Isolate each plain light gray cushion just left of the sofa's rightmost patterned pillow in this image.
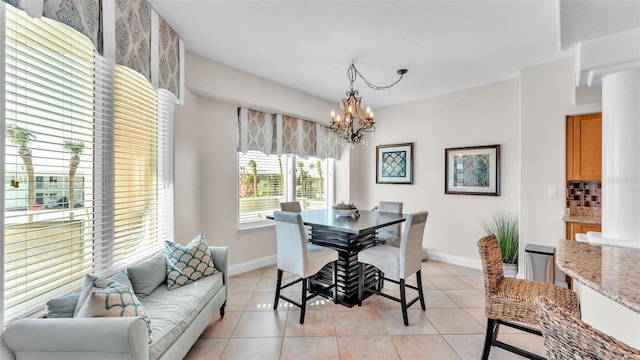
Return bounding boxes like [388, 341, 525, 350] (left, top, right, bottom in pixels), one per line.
[127, 251, 167, 299]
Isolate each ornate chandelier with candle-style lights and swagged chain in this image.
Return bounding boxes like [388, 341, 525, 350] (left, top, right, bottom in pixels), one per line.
[329, 63, 408, 146]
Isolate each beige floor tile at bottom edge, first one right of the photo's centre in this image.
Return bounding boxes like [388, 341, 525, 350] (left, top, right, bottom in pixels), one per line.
[338, 336, 400, 360]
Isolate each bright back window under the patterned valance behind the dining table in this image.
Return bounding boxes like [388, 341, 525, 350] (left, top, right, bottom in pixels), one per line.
[238, 151, 332, 229]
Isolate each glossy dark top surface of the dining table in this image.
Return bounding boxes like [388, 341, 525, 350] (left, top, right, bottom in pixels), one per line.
[267, 209, 408, 234]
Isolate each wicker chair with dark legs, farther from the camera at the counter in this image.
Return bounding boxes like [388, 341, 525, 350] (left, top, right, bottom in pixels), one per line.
[478, 235, 580, 359]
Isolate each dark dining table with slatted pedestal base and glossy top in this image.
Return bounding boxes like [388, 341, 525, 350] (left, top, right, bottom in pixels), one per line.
[267, 209, 408, 307]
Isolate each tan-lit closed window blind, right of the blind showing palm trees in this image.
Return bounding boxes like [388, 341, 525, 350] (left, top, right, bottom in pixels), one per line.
[112, 65, 158, 270]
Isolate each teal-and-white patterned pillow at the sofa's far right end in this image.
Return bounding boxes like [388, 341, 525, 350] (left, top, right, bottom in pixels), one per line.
[165, 234, 216, 290]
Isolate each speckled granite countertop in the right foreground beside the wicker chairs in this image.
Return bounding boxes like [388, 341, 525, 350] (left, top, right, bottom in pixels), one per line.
[556, 240, 640, 313]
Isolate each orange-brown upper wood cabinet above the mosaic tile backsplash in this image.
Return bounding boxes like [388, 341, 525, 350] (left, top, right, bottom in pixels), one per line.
[567, 113, 602, 180]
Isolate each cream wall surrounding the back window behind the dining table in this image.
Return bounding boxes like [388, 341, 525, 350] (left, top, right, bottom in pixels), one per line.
[175, 54, 338, 273]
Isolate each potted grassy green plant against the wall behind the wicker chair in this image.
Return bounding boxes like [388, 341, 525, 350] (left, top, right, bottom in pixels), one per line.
[482, 211, 520, 277]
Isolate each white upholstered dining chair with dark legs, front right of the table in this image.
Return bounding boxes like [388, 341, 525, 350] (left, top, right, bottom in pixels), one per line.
[358, 211, 429, 326]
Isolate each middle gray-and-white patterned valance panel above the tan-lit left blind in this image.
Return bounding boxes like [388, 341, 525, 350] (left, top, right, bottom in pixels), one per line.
[115, 0, 151, 81]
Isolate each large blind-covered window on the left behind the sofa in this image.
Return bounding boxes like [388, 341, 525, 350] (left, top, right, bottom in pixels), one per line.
[0, 5, 173, 322]
